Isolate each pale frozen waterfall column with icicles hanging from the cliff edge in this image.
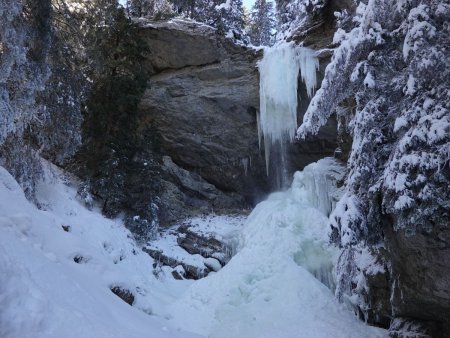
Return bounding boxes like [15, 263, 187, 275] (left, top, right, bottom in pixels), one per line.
[257, 43, 319, 174]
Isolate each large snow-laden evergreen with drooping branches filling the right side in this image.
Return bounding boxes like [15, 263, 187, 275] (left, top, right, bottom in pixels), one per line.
[299, 0, 450, 321]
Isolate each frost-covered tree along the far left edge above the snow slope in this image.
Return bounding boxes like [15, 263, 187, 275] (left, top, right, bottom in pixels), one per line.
[0, 0, 51, 197]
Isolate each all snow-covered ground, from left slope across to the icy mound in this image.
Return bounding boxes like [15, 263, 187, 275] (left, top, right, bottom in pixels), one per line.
[0, 163, 385, 338]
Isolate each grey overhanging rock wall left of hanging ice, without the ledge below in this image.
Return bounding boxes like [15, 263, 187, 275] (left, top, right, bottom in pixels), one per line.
[140, 20, 269, 206]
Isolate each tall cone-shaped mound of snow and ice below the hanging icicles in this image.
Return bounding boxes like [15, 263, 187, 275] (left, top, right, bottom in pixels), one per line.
[169, 160, 385, 337]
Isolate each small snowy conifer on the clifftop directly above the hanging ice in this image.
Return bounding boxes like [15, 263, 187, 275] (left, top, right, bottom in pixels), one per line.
[249, 0, 276, 46]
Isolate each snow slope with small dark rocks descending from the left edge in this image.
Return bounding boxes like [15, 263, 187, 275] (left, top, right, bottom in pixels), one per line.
[0, 162, 196, 338]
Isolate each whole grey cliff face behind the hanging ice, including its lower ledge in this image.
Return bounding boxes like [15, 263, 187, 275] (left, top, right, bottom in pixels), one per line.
[140, 20, 336, 223]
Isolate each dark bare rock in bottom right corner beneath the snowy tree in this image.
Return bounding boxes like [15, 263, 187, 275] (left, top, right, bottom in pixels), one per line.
[385, 222, 450, 337]
